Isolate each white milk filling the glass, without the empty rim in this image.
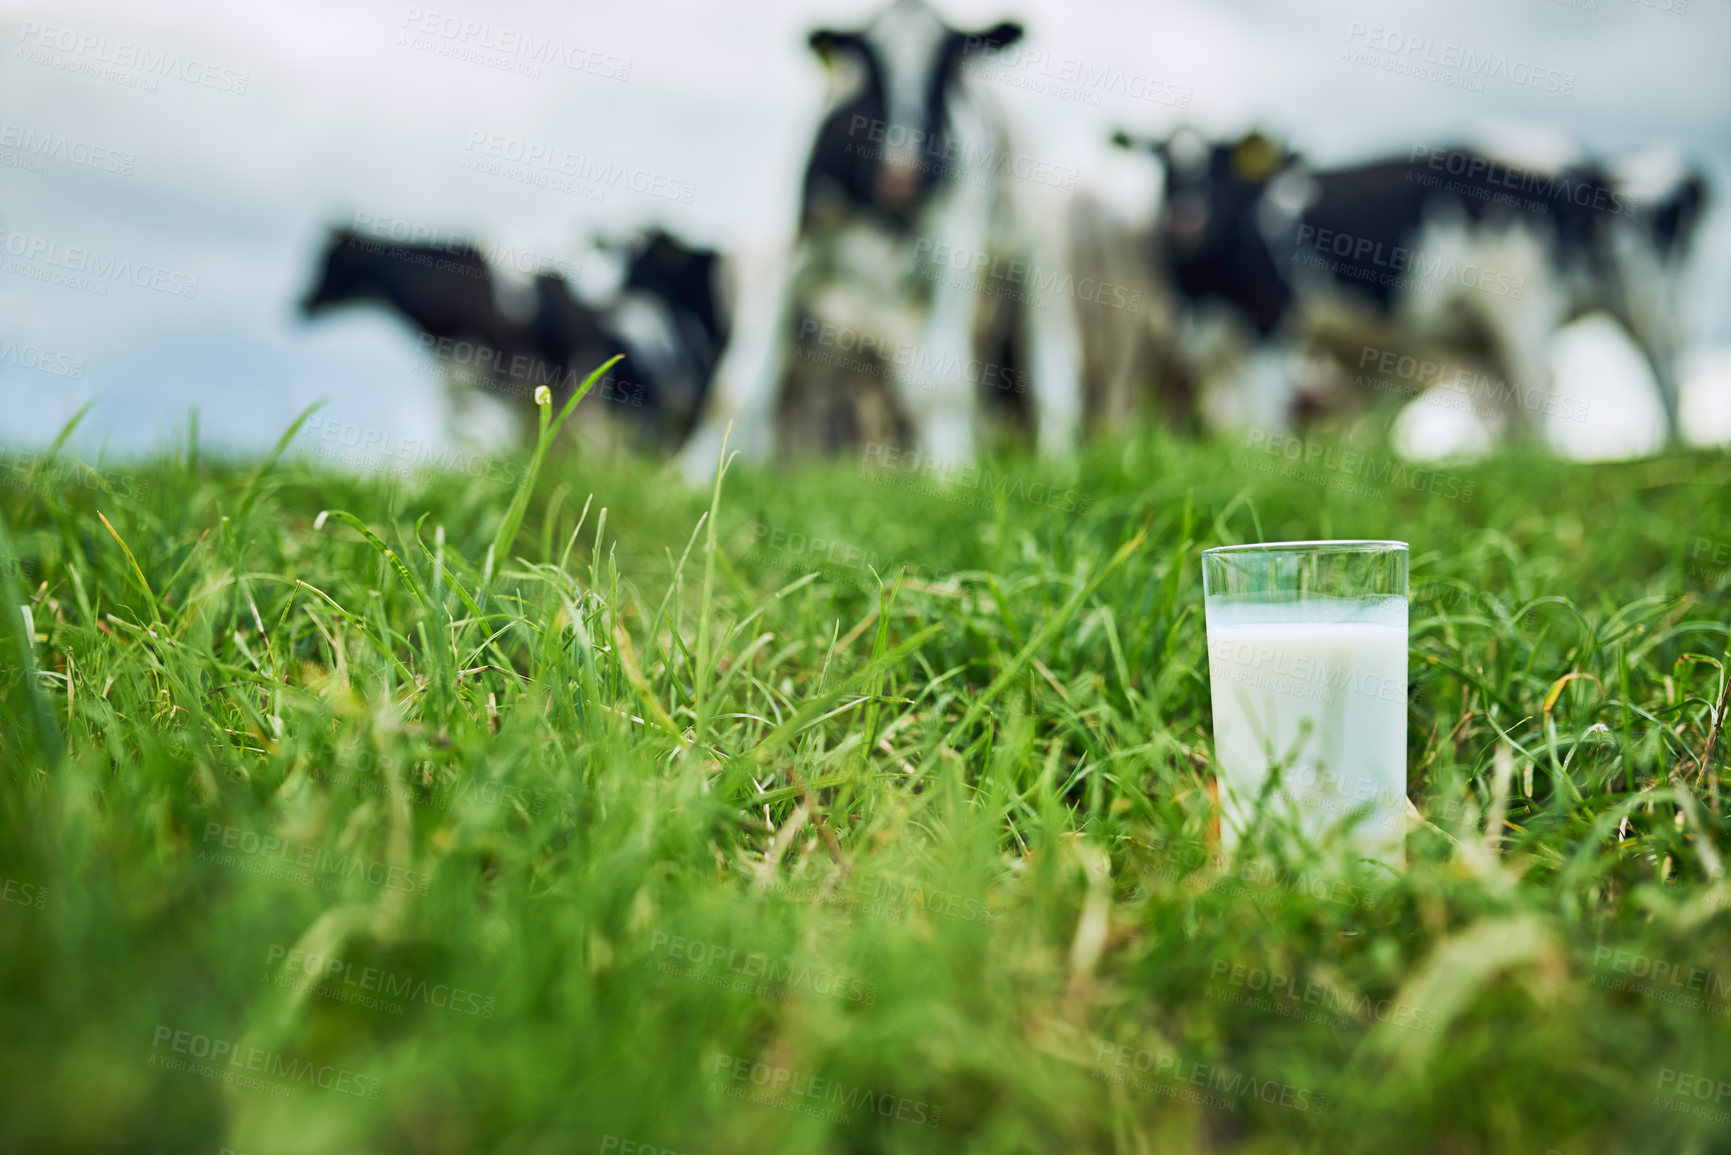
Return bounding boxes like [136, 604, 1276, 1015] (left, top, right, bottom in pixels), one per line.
[1207, 597, 1407, 866]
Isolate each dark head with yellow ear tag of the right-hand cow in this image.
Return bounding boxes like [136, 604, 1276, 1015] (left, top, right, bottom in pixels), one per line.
[1113, 128, 1300, 263]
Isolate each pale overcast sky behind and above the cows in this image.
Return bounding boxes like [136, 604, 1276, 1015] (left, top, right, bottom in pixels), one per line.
[0, 0, 1731, 452]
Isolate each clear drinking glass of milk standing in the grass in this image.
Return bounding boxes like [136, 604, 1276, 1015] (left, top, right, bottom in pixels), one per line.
[1201, 542, 1407, 868]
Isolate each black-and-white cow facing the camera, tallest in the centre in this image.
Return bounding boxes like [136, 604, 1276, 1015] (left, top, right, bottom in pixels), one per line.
[682, 0, 1078, 481]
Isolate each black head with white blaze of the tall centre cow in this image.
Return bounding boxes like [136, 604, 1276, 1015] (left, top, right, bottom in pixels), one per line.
[803, 0, 1021, 225]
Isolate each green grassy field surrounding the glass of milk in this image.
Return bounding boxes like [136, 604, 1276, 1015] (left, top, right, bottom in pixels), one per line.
[0, 393, 1731, 1155]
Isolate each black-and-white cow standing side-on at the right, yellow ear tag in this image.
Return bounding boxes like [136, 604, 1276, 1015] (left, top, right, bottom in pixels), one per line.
[1118, 132, 1705, 438]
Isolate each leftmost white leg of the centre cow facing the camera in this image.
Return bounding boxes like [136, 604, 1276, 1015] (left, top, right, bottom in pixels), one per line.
[677, 251, 798, 485]
